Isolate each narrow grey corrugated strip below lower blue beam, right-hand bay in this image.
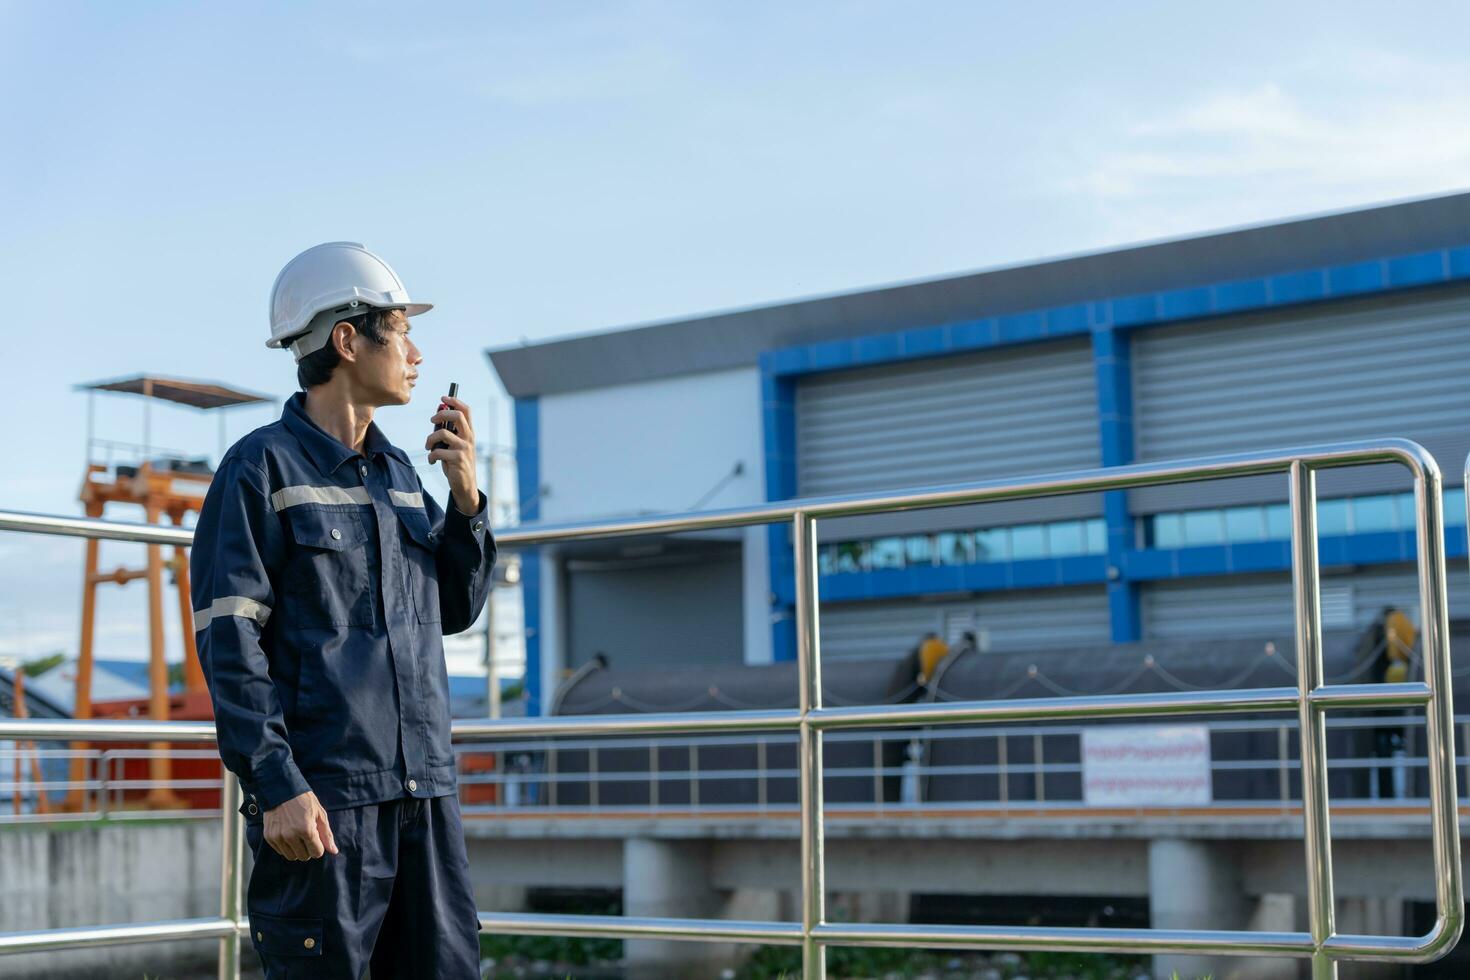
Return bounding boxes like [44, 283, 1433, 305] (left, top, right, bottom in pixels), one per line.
[1141, 560, 1470, 639]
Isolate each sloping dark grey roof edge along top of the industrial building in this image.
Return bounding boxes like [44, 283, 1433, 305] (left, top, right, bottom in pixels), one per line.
[487, 192, 1470, 398]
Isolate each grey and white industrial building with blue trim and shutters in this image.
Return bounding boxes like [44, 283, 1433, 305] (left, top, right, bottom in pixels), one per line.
[490, 194, 1470, 714]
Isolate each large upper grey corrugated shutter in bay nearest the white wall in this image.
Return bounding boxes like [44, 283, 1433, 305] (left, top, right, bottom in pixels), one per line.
[797, 334, 1101, 539]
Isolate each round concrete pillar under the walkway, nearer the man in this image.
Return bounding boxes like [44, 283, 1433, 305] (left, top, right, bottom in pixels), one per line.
[623, 837, 736, 980]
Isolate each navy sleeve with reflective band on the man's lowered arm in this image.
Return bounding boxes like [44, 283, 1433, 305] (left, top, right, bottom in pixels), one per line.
[190, 458, 310, 810]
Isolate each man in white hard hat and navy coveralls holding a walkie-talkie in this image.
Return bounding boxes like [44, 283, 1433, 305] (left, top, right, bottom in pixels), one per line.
[190, 242, 495, 980]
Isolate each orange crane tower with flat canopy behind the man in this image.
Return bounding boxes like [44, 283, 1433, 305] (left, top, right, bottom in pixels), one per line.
[66, 375, 275, 811]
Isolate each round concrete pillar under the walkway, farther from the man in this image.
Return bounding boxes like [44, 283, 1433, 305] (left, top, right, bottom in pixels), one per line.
[1148, 837, 1255, 980]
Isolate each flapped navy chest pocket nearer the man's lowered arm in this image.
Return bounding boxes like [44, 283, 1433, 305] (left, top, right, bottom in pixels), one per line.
[282, 505, 373, 626]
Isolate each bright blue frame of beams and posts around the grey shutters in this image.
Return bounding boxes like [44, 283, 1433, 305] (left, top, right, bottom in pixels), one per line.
[758, 244, 1470, 637]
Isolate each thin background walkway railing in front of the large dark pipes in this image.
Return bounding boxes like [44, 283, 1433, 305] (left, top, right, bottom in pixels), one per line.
[0, 714, 1446, 824]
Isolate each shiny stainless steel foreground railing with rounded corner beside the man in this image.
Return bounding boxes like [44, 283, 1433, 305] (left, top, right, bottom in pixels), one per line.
[0, 439, 1470, 980]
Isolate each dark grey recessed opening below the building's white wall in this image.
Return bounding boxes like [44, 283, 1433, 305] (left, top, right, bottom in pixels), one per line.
[566, 547, 745, 669]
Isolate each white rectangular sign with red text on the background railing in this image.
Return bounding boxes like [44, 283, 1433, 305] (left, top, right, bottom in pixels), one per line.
[1082, 724, 1211, 807]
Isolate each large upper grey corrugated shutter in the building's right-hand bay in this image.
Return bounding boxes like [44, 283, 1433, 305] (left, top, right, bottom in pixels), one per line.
[1129, 288, 1470, 513]
